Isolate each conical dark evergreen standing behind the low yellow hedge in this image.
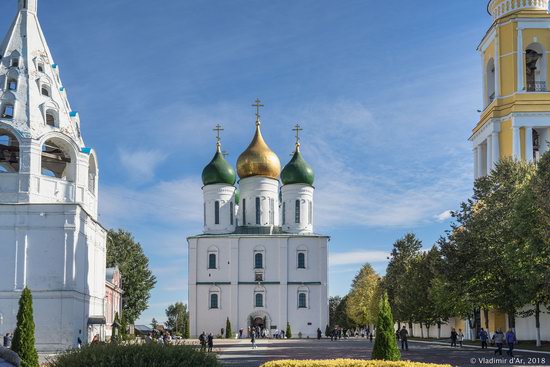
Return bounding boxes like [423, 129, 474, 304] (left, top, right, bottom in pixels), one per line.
[372, 294, 401, 361]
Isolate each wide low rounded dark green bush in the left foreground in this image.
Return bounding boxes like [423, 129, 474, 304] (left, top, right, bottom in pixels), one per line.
[48, 344, 220, 367]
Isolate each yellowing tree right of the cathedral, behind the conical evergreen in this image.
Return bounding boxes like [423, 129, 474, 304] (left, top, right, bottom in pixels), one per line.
[346, 264, 380, 326]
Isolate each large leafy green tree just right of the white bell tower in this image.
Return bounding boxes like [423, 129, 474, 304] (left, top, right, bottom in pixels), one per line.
[107, 229, 157, 324]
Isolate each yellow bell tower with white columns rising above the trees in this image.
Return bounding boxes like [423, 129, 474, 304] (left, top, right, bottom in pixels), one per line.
[469, 0, 550, 178]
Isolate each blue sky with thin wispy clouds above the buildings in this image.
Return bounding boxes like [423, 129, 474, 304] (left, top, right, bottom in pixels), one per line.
[0, 0, 491, 324]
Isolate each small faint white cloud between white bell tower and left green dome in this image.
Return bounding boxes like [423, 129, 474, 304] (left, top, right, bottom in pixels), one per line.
[118, 148, 168, 182]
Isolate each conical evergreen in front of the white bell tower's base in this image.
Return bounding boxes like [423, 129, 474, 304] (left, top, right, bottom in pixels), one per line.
[12, 287, 39, 367]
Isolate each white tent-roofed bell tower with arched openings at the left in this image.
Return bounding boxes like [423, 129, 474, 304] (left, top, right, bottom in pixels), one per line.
[0, 0, 106, 352]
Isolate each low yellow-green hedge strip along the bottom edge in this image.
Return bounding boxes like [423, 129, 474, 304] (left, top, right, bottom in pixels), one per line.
[261, 359, 451, 367]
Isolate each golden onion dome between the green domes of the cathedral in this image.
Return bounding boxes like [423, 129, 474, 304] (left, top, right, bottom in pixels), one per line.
[237, 120, 281, 180]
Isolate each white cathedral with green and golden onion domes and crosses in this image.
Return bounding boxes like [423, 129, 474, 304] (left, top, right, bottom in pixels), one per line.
[188, 101, 329, 337]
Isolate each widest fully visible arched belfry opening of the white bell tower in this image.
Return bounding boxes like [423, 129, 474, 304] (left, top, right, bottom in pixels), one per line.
[42, 139, 75, 182]
